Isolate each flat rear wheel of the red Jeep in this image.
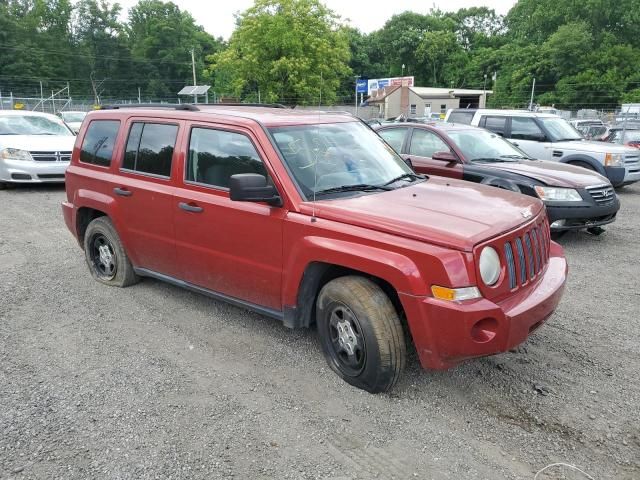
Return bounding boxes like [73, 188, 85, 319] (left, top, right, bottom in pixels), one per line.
[84, 217, 140, 287]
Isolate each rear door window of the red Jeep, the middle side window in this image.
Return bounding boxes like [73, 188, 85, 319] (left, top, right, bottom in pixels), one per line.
[122, 122, 178, 177]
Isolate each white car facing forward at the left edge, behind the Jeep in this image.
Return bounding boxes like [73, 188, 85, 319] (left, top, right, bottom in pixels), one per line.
[0, 110, 75, 189]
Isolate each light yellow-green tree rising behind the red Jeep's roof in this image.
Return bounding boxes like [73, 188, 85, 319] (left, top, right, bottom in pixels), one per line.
[209, 0, 351, 104]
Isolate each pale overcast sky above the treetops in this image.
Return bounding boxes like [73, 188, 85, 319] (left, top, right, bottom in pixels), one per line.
[118, 0, 516, 39]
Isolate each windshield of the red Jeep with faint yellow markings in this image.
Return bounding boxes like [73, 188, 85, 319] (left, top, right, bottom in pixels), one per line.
[269, 122, 417, 199]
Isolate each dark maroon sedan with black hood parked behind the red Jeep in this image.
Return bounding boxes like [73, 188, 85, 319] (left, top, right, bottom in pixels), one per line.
[377, 123, 620, 235]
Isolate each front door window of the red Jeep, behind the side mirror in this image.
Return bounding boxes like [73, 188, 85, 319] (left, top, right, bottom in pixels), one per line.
[185, 127, 267, 188]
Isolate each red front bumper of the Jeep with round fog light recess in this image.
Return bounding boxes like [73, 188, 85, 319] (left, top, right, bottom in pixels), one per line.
[400, 242, 568, 370]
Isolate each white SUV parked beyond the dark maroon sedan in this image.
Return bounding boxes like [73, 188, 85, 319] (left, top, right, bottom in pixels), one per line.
[446, 109, 640, 187]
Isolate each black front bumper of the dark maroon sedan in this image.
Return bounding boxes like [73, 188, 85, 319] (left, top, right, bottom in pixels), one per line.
[545, 194, 620, 232]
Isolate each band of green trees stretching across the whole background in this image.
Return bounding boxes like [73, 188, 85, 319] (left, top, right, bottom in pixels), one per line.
[0, 0, 640, 108]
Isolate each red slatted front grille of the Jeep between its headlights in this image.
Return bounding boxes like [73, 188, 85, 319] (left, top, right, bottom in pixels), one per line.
[504, 218, 551, 290]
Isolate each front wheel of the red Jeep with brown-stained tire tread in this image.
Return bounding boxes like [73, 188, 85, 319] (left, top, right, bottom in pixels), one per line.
[316, 276, 407, 393]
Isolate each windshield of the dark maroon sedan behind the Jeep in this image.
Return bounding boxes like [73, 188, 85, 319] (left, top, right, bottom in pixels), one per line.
[448, 130, 529, 162]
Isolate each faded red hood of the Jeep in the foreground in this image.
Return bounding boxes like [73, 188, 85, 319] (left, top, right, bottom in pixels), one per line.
[301, 177, 543, 251]
